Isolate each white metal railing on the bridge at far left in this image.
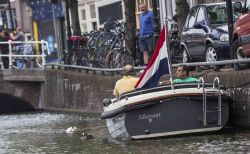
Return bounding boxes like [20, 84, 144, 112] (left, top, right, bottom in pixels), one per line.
[0, 40, 50, 69]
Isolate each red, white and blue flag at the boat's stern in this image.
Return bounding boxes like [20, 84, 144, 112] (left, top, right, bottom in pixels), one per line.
[135, 26, 169, 88]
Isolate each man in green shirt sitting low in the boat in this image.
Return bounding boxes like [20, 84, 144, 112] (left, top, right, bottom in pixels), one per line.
[174, 65, 198, 83]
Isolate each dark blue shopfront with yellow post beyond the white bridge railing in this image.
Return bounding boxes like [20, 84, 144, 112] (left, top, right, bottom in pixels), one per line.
[30, 0, 66, 58]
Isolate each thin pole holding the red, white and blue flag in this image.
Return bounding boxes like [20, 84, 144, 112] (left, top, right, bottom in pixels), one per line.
[165, 18, 174, 90]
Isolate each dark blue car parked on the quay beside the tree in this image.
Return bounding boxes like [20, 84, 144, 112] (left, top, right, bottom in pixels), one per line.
[181, 2, 238, 63]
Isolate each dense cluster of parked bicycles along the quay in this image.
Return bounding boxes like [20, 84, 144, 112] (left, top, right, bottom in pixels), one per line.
[65, 18, 134, 68]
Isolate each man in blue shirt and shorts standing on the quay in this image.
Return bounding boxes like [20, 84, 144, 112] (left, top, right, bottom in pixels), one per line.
[139, 3, 154, 65]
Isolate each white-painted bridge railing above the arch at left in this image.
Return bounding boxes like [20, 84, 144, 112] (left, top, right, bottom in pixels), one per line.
[0, 40, 50, 69]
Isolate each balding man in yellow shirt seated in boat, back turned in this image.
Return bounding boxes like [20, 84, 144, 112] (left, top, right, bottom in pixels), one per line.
[113, 64, 139, 99]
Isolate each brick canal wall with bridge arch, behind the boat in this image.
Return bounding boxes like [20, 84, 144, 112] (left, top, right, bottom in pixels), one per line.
[0, 65, 250, 127]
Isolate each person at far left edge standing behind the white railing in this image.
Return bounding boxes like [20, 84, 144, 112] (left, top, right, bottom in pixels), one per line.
[0, 30, 11, 69]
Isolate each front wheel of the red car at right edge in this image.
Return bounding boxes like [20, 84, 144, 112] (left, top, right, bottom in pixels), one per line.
[231, 39, 248, 67]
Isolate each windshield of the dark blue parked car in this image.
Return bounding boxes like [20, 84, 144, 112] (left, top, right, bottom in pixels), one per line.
[207, 4, 240, 25]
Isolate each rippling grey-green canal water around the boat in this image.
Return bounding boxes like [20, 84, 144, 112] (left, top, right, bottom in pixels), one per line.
[0, 112, 250, 154]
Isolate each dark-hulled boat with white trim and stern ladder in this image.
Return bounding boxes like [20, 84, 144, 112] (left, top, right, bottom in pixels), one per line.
[101, 77, 231, 139]
